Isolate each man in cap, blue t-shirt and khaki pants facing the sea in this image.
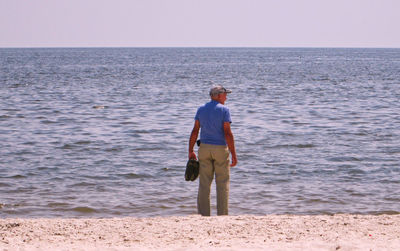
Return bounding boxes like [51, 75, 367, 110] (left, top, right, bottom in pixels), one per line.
[189, 85, 237, 216]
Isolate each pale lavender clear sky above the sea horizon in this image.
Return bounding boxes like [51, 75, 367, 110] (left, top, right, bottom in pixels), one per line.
[0, 0, 400, 48]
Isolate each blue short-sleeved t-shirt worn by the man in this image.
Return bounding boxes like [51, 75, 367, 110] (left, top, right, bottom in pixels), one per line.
[195, 100, 232, 146]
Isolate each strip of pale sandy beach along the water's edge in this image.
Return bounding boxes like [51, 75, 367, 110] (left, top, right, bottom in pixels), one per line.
[0, 215, 400, 250]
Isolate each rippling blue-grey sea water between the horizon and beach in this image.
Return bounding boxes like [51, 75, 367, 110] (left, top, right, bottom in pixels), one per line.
[0, 48, 400, 217]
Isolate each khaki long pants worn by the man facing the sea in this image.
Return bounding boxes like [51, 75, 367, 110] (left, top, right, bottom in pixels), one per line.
[197, 144, 230, 216]
